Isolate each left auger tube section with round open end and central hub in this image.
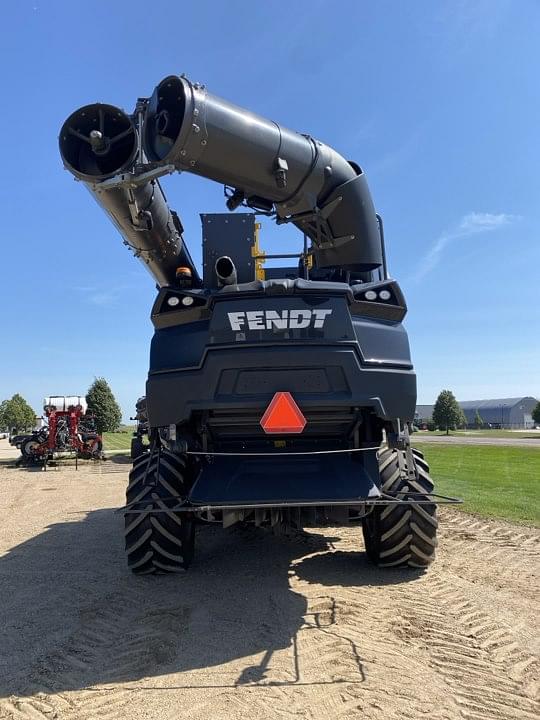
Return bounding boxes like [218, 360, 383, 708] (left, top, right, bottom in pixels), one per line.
[59, 103, 201, 286]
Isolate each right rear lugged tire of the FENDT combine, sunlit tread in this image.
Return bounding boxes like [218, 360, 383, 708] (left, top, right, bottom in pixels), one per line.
[362, 448, 437, 568]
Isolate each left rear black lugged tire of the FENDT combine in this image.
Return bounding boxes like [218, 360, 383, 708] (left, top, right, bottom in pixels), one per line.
[124, 449, 195, 575]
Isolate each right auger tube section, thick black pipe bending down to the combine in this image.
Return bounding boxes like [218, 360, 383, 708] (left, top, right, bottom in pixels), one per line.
[143, 75, 382, 271]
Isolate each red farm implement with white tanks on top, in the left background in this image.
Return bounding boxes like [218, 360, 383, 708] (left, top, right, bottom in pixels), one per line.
[19, 395, 103, 470]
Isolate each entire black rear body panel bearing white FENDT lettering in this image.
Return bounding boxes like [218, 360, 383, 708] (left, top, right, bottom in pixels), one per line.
[147, 283, 416, 432]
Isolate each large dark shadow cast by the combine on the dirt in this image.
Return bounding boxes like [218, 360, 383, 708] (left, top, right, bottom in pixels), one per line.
[0, 510, 422, 697]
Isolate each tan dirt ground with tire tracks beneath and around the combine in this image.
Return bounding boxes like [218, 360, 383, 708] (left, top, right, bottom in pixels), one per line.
[0, 450, 540, 720]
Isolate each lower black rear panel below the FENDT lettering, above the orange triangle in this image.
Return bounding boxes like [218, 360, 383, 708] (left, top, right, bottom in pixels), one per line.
[146, 345, 416, 427]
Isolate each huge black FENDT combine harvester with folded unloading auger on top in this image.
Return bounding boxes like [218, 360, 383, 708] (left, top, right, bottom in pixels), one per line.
[60, 76, 448, 574]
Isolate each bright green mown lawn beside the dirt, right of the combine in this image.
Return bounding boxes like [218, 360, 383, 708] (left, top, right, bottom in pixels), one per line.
[414, 436, 540, 527]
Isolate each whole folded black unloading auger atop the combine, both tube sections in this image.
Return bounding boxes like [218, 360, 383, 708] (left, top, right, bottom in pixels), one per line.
[60, 76, 383, 285]
